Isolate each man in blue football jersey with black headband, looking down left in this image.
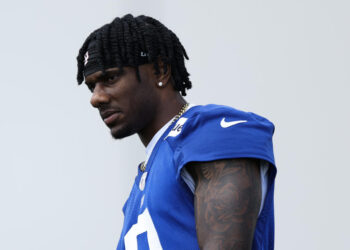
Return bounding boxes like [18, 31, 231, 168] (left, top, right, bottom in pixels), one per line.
[77, 15, 276, 250]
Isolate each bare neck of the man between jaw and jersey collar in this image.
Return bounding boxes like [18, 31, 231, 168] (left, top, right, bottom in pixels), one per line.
[138, 94, 186, 147]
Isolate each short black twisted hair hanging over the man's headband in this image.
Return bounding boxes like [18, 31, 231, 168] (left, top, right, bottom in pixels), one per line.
[77, 14, 192, 96]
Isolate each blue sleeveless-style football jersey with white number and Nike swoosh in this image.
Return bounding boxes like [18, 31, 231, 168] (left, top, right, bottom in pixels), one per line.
[117, 105, 276, 250]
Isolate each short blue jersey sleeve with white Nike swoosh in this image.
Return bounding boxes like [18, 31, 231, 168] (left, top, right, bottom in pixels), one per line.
[170, 106, 275, 178]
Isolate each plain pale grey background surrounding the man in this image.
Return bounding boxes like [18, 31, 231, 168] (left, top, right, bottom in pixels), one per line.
[0, 0, 350, 250]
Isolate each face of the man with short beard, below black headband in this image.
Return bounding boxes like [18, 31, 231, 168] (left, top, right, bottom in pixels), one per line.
[85, 64, 158, 139]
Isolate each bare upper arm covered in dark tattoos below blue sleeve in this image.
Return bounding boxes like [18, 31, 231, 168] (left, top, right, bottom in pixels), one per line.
[186, 159, 261, 250]
